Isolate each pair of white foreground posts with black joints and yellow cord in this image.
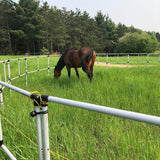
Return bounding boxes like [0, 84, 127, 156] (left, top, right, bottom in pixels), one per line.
[31, 94, 50, 160]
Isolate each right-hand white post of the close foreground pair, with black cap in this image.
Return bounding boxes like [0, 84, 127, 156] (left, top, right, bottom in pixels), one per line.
[42, 95, 50, 160]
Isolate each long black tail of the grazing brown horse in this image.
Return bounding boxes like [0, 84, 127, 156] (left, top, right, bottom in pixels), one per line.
[82, 49, 94, 72]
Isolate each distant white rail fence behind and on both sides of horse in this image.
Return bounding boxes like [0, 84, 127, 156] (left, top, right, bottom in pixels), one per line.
[0, 53, 160, 85]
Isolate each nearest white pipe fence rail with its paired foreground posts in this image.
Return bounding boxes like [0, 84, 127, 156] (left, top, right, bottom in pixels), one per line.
[0, 81, 160, 160]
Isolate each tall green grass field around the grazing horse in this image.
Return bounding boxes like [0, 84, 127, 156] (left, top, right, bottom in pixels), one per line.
[0, 57, 160, 160]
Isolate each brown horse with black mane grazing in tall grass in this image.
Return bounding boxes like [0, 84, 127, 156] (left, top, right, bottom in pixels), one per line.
[54, 48, 96, 82]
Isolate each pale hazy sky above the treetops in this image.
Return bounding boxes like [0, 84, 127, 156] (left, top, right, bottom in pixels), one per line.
[14, 0, 160, 32]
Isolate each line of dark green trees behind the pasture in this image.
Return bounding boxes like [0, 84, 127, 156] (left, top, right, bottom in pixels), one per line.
[0, 0, 160, 55]
